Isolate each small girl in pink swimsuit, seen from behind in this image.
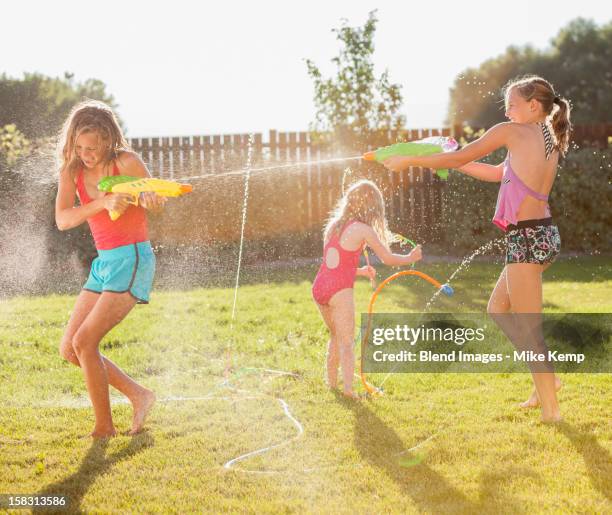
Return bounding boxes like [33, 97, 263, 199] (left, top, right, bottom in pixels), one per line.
[312, 180, 421, 398]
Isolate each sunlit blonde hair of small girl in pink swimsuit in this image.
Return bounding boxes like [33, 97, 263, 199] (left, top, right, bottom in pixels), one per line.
[323, 179, 392, 248]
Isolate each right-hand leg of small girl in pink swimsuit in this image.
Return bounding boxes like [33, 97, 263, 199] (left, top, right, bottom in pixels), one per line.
[329, 288, 355, 397]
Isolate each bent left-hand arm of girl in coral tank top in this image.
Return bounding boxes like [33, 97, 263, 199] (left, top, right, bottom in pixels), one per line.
[55, 170, 129, 231]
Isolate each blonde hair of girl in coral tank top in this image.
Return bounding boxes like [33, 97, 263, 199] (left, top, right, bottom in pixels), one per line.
[57, 100, 131, 175]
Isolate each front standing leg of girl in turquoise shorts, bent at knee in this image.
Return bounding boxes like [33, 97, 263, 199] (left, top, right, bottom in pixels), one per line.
[72, 292, 150, 437]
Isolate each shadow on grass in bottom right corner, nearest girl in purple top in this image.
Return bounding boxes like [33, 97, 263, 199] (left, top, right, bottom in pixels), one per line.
[555, 422, 612, 501]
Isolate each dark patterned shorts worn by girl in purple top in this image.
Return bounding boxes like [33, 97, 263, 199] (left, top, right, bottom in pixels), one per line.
[506, 218, 561, 265]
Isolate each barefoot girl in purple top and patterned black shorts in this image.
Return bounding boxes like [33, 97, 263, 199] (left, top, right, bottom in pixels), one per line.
[384, 76, 571, 422]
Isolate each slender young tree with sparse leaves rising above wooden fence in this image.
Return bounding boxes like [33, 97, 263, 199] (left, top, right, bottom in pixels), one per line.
[306, 11, 404, 148]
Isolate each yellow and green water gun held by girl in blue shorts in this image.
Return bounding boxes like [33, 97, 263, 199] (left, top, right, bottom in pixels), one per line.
[98, 175, 193, 221]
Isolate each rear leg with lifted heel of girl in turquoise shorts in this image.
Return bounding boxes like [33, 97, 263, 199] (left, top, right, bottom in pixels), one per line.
[60, 290, 155, 430]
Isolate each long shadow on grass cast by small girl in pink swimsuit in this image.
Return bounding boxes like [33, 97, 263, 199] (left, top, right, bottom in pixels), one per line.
[339, 396, 538, 513]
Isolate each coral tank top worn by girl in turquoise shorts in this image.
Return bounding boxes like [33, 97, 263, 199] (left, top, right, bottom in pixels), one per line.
[76, 163, 149, 250]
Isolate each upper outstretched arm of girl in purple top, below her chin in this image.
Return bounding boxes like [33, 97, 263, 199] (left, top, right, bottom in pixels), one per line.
[383, 122, 514, 172]
